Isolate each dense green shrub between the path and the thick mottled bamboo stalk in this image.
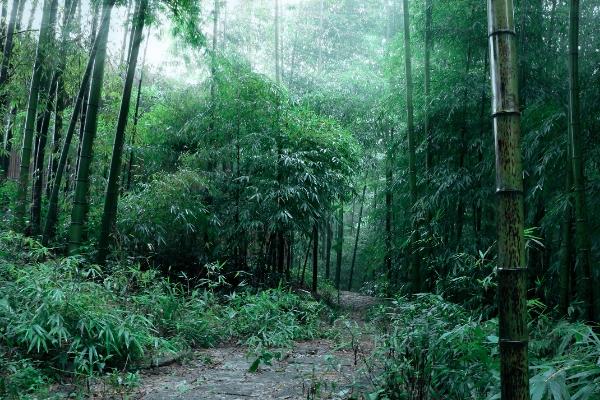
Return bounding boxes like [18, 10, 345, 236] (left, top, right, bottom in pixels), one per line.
[380, 295, 498, 399]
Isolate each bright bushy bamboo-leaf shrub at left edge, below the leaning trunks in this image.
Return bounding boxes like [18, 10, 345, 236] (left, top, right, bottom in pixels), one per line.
[0, 258, 165, 375]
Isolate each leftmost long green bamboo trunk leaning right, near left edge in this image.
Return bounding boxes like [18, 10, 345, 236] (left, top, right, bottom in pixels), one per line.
[15, 0, 57, 232]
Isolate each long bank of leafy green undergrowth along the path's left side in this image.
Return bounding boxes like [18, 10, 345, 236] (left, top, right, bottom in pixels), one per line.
[0, 233, 324, 398]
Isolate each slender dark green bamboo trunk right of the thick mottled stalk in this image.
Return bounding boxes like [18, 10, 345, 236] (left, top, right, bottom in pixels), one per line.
[569, 0, 598, 321]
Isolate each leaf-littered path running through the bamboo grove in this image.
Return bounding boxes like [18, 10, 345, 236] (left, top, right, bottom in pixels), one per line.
[128, 292, 377, 400]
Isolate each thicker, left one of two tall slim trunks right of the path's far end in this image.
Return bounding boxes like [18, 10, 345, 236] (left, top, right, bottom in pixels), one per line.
[402, 0, 422, 293]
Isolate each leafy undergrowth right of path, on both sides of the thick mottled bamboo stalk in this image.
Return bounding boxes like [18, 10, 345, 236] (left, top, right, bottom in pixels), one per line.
[373, 294, 600, 400]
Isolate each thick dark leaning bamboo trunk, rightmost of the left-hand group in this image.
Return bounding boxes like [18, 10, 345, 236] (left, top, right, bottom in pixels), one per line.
[98, 0, 148, 265]
